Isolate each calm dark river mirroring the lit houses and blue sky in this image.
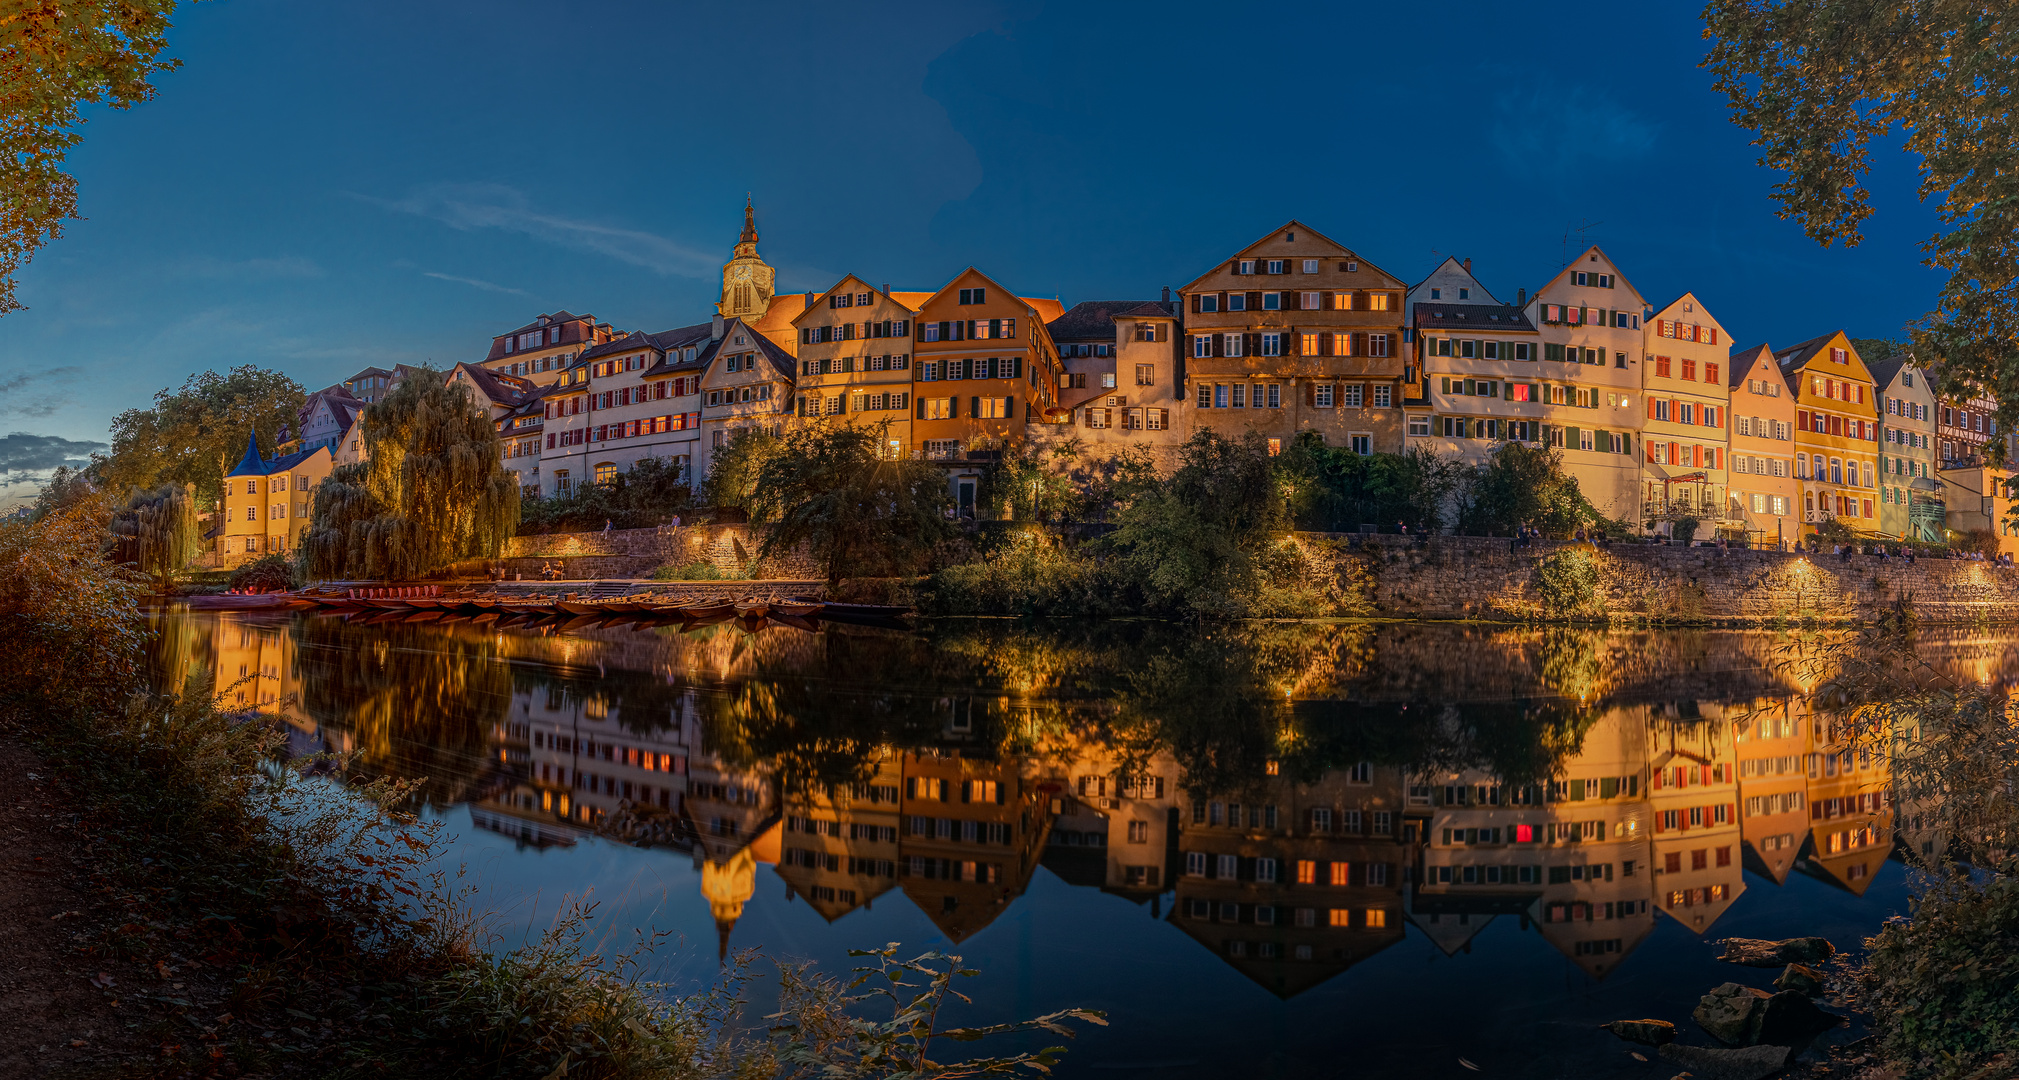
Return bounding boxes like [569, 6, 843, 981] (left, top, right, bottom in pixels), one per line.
[142, 612, 2019, 1078]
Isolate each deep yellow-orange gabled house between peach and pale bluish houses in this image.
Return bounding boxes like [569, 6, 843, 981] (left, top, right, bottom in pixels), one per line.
[1775, 329, 1880, 535]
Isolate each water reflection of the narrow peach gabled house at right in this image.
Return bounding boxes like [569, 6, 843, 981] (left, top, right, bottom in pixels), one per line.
[1732, 696, 1813, 884]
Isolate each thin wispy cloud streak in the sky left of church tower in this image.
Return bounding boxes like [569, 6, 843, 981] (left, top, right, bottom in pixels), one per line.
[353, 184, 721, 279]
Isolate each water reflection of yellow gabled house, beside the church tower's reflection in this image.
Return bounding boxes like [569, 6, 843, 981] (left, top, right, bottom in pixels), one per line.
[777, 749, 902, 923]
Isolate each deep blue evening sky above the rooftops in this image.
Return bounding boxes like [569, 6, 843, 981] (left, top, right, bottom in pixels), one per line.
[0, 0, 1938, 497]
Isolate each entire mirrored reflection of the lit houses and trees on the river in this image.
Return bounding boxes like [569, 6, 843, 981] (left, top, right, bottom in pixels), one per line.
[157, 614, 1970, 1013]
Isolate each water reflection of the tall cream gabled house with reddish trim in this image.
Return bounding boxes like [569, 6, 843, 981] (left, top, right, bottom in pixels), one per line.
[1648, 700, 1746, 935]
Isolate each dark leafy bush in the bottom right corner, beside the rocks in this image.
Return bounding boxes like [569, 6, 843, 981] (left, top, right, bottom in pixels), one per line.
[1857, 862, 2019, 1078]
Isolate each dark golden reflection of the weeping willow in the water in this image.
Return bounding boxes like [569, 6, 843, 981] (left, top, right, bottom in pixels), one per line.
[293, 618, 511, 803]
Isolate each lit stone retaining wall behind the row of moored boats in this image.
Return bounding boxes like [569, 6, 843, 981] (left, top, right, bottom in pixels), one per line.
[501, 525, 820, 579]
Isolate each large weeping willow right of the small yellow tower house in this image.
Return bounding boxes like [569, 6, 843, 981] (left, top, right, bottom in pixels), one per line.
[303, 367, 519, 579]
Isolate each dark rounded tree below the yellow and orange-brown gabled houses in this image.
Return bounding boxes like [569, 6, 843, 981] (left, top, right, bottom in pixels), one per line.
[749, 422, 953, 583]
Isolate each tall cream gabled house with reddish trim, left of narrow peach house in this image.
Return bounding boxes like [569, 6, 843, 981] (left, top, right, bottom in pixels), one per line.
[1639, 293, 1742, 543]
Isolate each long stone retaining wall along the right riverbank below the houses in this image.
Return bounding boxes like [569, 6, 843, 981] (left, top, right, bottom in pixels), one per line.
[1324, 533, 2019, 622]
